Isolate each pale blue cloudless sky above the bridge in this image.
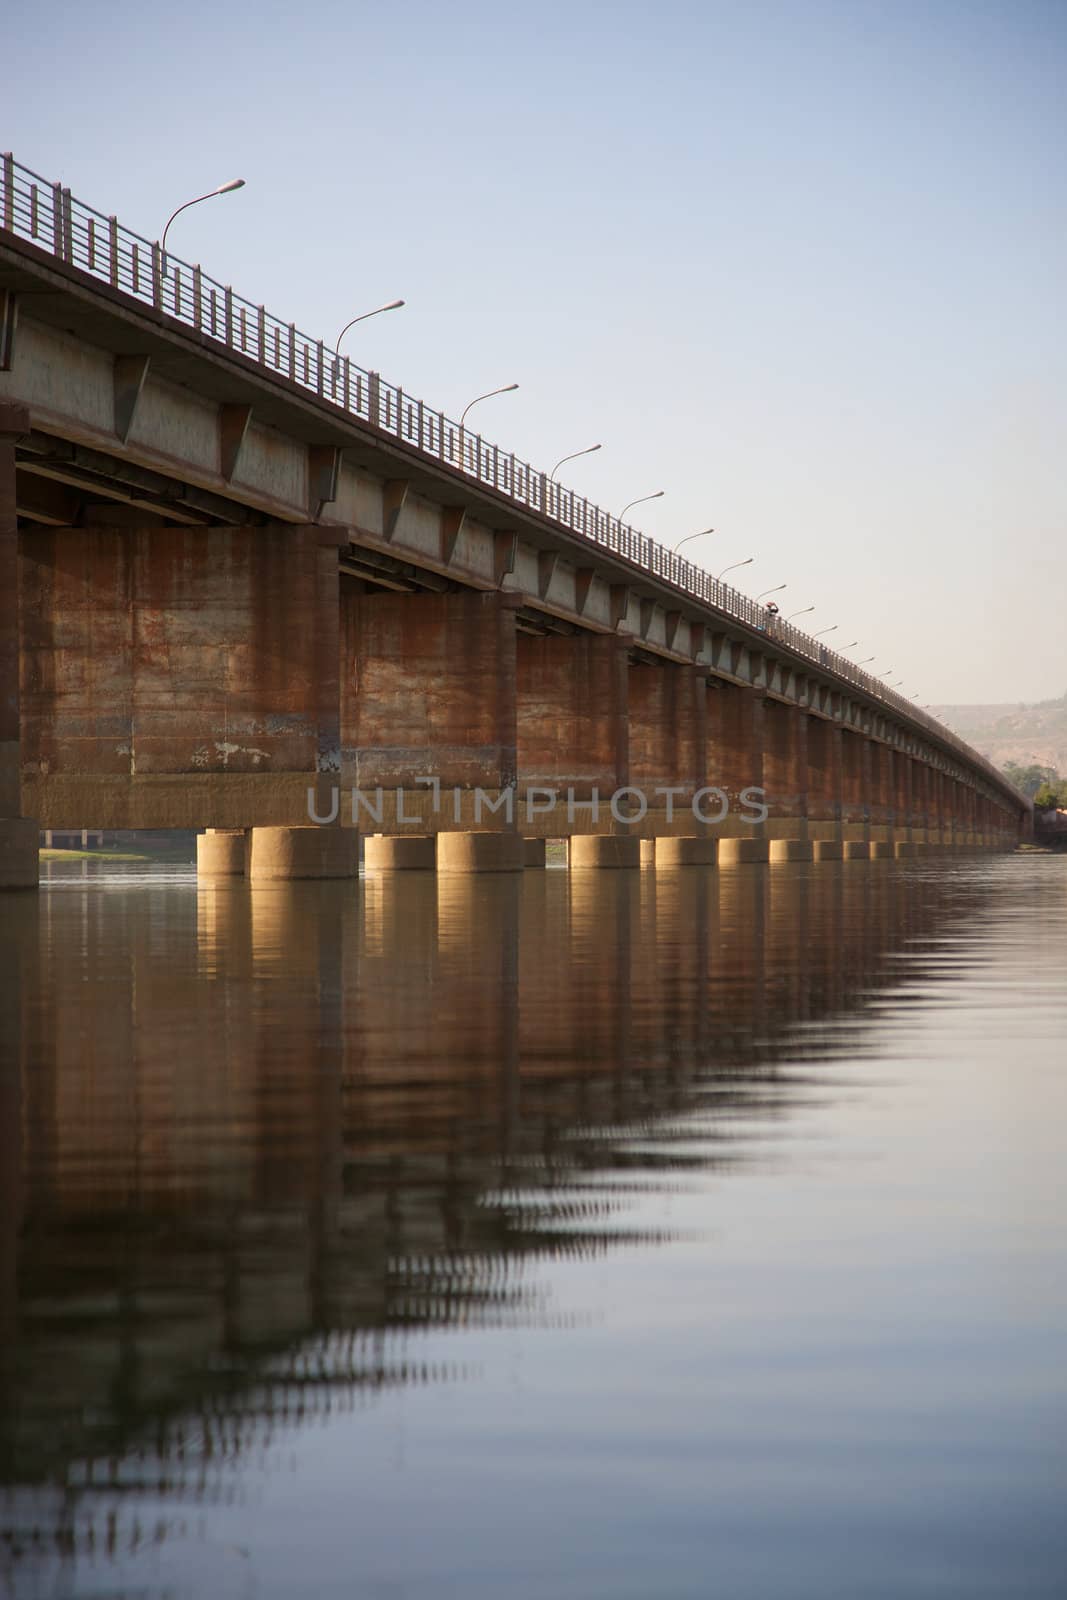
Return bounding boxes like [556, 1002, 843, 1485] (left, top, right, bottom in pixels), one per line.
[8, 0, 1067, 704]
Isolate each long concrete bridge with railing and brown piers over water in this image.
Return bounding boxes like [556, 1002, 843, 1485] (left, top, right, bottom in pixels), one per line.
[0, 155, 1030, 885]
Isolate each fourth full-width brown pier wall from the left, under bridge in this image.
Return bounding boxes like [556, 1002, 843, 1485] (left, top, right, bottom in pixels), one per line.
[629, 659, 715, 838]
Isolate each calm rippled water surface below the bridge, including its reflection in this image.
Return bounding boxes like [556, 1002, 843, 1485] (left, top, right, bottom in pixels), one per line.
[0, 856, 1067, 1600]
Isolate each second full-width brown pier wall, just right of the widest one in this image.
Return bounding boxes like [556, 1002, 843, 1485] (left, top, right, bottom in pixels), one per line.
[341, 586, 518, 832]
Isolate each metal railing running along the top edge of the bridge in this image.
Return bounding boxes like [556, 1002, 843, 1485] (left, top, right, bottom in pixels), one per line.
[0, 155, 1011, 792]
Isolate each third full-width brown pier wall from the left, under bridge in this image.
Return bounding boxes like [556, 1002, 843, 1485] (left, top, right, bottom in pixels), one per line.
[515, 634, 629, 838]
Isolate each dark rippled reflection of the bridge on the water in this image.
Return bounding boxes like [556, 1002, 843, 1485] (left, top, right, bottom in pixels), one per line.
[0, 864, 987, 1557]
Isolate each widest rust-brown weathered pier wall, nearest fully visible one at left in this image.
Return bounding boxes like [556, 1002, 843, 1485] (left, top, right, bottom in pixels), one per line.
[21, 526, 339, 827]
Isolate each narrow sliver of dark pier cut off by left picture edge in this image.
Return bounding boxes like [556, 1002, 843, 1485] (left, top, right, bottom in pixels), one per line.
[0, 400, 38, 890]
